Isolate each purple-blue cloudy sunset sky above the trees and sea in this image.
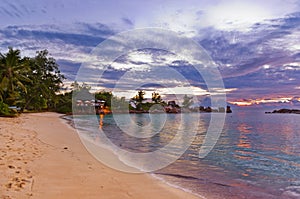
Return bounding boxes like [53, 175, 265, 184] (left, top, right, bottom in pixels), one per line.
[0, 0, 300, 107]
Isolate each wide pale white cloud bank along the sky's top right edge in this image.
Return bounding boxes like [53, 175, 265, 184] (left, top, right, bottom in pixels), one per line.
[130, 0, 299, 37]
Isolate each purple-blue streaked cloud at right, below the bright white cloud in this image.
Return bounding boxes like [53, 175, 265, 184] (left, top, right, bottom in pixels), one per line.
[200, 13, 300, 81]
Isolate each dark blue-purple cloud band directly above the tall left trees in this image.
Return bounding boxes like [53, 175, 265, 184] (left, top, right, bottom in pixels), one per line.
[0, 23, 114, 65]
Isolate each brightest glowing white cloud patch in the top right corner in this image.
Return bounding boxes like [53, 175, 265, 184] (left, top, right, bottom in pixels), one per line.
[204, 0, 298, 31]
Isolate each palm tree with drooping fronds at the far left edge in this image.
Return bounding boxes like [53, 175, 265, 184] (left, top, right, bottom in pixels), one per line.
[0, 48, 30, 105]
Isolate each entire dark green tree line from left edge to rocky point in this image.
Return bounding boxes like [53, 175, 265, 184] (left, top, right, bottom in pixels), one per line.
[0, 48, 231, 116]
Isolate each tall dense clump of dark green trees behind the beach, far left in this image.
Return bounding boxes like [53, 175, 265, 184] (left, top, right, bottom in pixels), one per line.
[0, 48, 64, 115]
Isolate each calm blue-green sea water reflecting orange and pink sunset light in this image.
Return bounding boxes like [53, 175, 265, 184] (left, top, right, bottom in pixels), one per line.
[71, 110, 300, 198]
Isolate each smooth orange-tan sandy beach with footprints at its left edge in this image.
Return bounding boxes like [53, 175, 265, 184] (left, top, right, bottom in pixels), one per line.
[0, 113, 202, 199]
